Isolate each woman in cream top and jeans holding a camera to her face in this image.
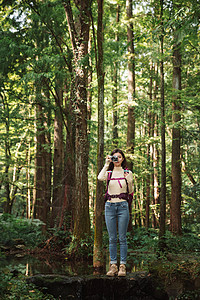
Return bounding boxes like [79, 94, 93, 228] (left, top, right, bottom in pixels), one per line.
[98, 149, 133, 276]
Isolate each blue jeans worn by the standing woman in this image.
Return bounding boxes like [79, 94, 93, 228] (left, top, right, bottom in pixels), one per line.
[105, 201, 129, 264]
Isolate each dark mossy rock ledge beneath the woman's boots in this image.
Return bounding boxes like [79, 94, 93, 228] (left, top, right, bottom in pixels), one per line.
[27, 272, 168, 300]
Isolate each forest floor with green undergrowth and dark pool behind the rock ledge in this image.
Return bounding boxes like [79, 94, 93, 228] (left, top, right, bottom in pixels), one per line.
[0, 216, 200, 299]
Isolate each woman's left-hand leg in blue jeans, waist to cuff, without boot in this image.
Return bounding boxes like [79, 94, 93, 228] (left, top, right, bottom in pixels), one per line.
[105, 202, 117, 264]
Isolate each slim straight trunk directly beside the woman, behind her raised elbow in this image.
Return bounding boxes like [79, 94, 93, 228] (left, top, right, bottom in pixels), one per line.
[93, 0, 104, 268]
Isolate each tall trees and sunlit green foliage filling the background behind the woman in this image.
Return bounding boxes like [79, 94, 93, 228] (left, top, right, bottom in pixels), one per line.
[0, 0, 200, 267]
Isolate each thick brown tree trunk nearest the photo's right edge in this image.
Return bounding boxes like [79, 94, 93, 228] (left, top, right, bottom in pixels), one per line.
[170, 33, 181, 235]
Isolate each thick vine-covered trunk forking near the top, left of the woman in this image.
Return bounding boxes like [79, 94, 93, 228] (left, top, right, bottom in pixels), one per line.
[63, 0, 91, 240]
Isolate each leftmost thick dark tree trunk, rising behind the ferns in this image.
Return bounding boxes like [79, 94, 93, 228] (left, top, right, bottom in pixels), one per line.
[32, 82, 51, 224]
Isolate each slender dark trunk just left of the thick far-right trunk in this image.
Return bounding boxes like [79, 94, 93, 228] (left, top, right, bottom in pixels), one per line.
[159, 0, 166, 244]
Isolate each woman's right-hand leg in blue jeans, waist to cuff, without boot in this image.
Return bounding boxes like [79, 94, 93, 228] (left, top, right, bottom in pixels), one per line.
[118, 201, 129, 264]
